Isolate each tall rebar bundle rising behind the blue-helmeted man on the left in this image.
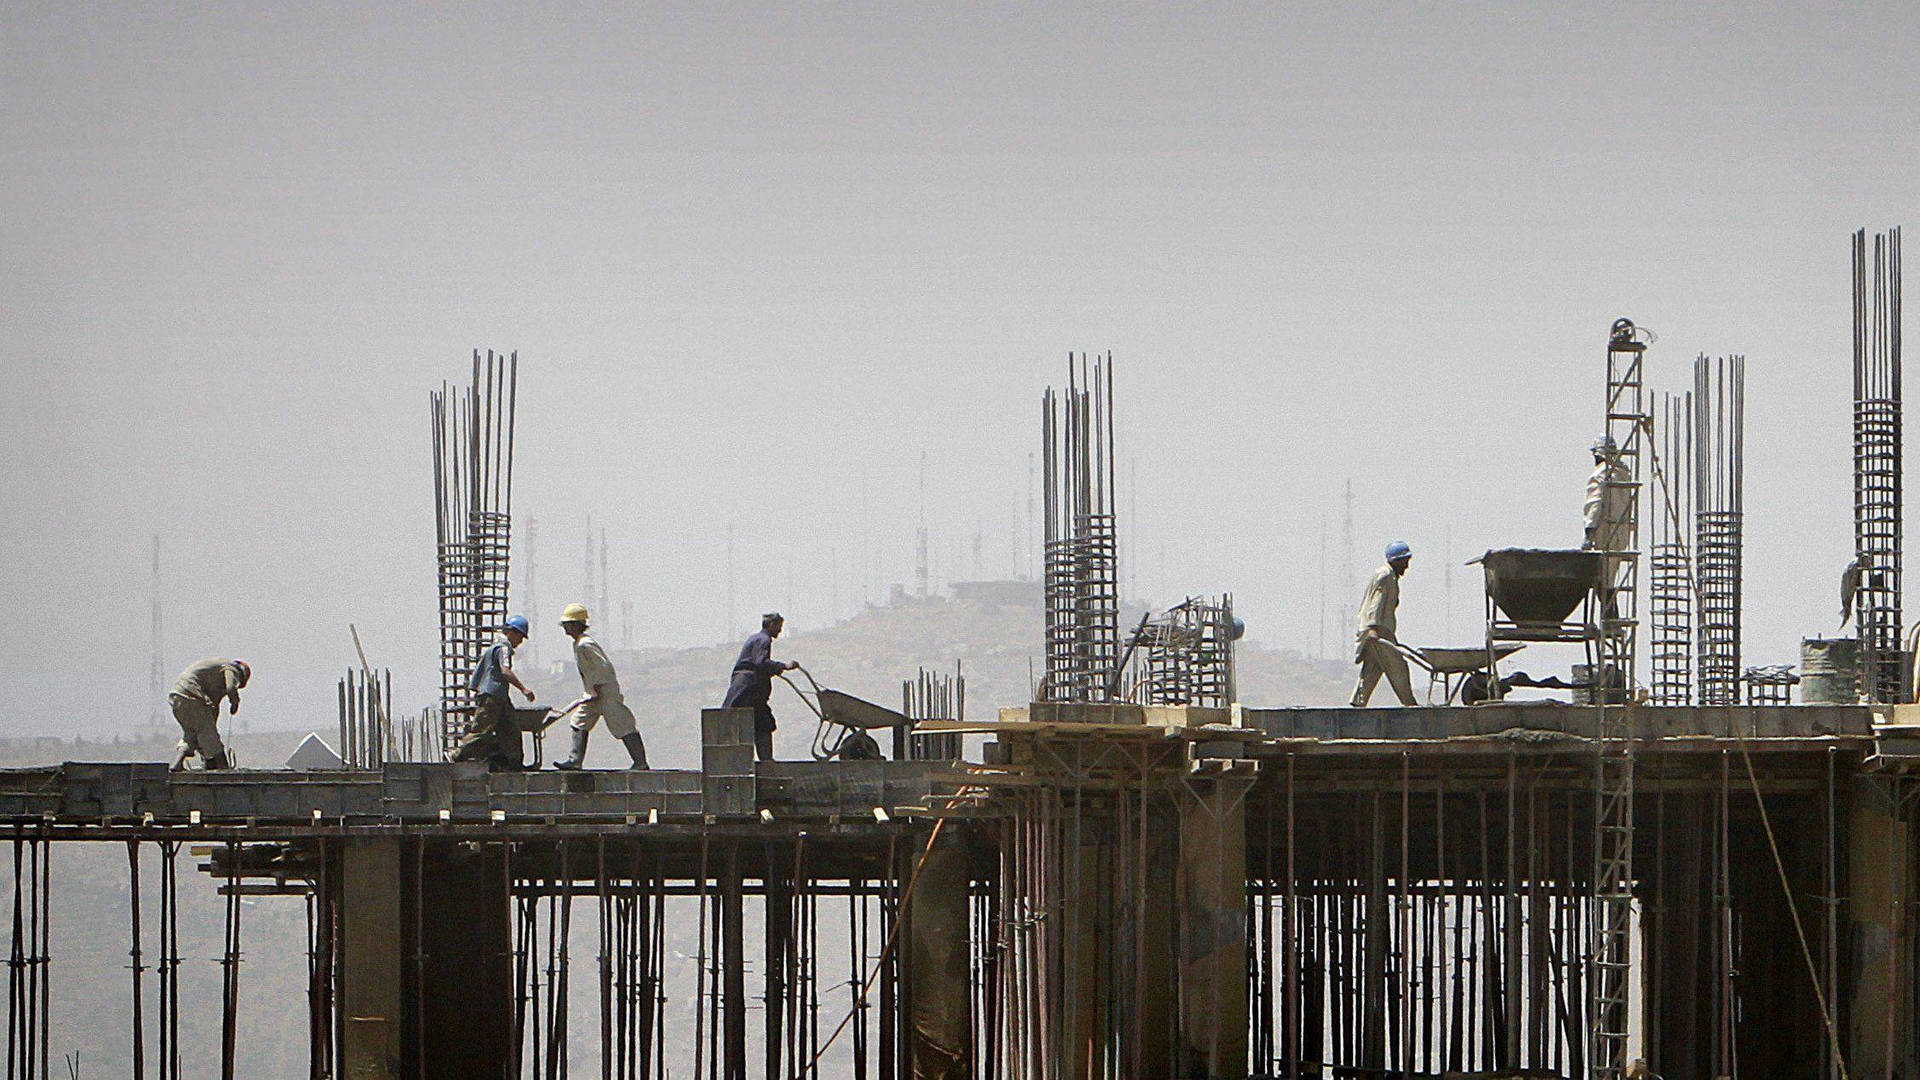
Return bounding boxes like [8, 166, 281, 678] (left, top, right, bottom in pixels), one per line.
[430, 350, 520, 749]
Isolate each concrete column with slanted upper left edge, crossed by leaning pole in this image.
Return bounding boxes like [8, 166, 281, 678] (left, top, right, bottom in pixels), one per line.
[900, 824, 973, 1080]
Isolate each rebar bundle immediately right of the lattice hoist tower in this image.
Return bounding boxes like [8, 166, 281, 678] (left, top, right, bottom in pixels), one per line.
[1647, 394, 1693, 705]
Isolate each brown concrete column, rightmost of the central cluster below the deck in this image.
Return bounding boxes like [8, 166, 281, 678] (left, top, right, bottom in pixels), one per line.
[1175, 778, 1252, 1080]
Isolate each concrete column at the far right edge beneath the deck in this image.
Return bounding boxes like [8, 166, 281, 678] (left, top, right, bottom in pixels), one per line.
[1845, 778, 1916, 1078]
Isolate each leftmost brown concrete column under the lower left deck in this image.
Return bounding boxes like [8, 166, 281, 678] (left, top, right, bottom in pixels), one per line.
[338, 838, 407, 1080]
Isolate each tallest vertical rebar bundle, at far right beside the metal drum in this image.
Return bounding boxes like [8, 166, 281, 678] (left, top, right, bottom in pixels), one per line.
[1853, 229, 1903, 701]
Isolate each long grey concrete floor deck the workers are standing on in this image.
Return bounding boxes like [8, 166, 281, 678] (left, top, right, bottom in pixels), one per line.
[0, 703, 1881, 838]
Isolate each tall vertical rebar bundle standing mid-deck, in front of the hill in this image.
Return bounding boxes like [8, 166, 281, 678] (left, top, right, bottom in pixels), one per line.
[1039, 356, 1119, 701]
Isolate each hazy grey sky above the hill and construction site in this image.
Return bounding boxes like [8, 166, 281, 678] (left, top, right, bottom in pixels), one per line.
[0, 4, 1920, 732]
